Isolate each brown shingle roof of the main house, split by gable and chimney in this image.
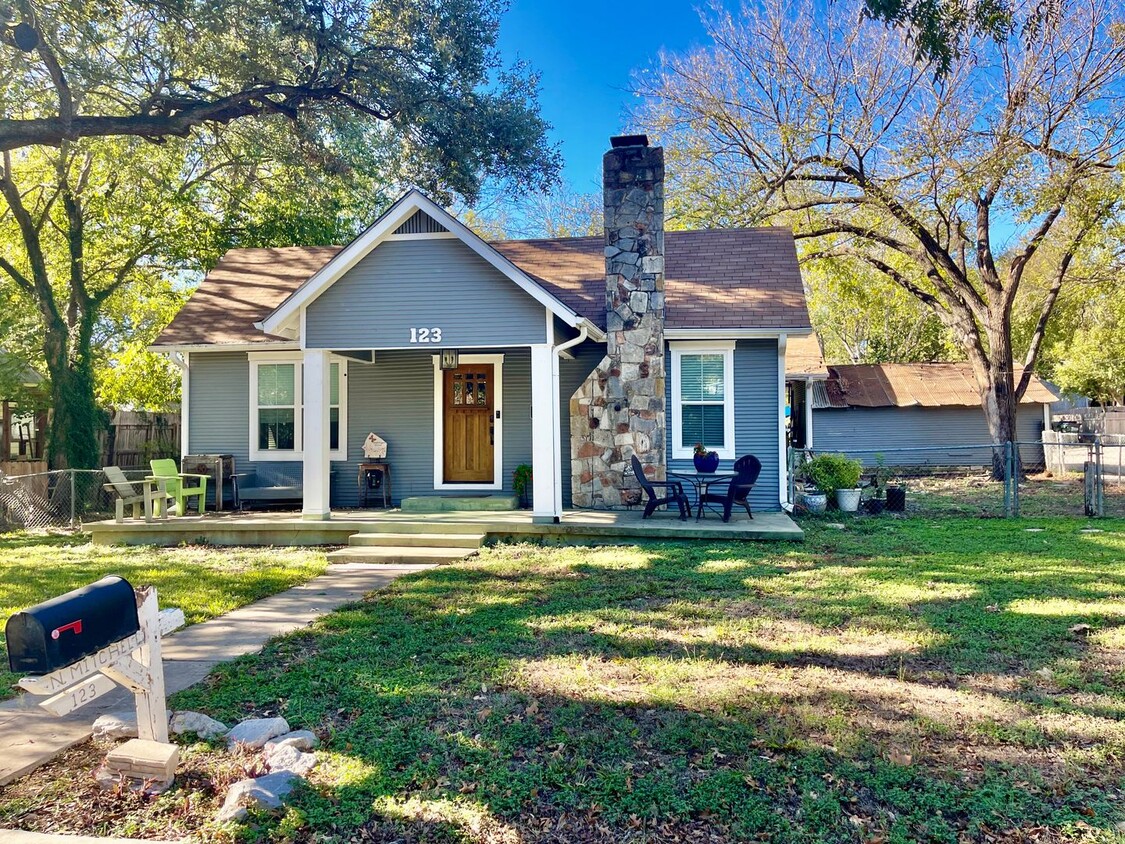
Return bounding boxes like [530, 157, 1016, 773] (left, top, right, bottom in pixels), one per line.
[156, 228, 809, 345]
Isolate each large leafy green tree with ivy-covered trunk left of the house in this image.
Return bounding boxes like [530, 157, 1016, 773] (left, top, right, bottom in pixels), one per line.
[0, 0, 558, 467]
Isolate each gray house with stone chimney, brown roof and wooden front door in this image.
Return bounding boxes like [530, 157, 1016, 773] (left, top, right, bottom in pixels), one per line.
[154, 135, 811, 521]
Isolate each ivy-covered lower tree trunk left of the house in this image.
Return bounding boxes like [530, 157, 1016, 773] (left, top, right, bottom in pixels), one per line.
[44, 330, 99, 469]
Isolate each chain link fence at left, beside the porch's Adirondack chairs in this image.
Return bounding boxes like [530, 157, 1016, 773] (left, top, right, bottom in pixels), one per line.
[0, 469, 151, 530]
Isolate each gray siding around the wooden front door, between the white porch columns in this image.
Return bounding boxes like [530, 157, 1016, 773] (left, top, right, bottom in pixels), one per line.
[332, 349, 531, 508]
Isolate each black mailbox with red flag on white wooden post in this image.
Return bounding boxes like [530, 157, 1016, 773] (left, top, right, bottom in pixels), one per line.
[5, 575, 141, 674]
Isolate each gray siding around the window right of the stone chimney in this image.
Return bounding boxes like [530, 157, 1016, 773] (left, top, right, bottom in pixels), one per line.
[667, 340, 781, 517]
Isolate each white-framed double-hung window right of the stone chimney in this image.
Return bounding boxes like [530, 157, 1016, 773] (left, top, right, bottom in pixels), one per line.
[672, 342, 735, 459]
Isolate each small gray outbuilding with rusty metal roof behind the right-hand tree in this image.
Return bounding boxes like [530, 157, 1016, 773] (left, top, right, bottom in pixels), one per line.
[790, 362, 1058, 466]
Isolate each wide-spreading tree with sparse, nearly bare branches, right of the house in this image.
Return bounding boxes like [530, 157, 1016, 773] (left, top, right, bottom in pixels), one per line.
[641, 0, 1125, 463]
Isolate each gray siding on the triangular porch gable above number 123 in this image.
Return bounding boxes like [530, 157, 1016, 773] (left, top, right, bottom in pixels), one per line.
[305, 237, 547, 349]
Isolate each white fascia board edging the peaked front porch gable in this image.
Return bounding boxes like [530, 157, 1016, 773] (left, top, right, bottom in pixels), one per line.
[254, 188, 583, 334]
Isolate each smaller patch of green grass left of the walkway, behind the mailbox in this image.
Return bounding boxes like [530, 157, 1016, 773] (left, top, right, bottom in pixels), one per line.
[0, 533, 327, 699]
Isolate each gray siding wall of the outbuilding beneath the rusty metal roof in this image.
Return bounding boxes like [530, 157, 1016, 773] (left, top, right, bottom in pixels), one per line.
[812, 404, 1043, 466]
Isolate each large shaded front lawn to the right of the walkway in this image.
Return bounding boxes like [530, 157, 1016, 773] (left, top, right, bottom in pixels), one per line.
[0, 518, 1125, 844]
